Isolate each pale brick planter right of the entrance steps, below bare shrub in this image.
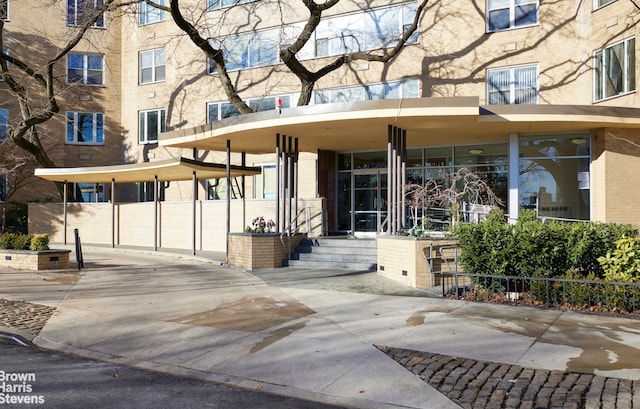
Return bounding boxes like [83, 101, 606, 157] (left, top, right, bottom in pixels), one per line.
[377, 236, 458, 288]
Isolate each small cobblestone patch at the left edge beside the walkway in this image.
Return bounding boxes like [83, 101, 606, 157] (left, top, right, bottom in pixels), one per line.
[0, 298, 56, 335]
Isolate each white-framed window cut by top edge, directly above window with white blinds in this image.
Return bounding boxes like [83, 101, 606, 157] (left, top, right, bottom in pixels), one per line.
[487, 0, 538, 31]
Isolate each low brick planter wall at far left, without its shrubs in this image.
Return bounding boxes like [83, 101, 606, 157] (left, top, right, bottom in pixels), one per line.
[0, 250, 71, 271]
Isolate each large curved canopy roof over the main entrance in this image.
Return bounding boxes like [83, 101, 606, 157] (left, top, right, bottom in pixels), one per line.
[159, 97, 640, 153]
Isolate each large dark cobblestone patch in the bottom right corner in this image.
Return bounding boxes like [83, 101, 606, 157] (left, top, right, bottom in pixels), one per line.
[378, 347, 640, 409]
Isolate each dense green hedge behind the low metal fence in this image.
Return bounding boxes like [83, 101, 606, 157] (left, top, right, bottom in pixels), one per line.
[454, 210, 638, 279]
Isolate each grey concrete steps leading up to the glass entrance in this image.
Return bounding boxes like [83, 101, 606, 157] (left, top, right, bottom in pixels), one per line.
[288, 237, 377, 271]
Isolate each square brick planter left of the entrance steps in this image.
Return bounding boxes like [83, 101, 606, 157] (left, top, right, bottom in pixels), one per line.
[229, 233, 305, 270]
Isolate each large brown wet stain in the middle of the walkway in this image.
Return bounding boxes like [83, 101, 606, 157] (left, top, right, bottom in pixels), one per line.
[173, 297, 315, 332]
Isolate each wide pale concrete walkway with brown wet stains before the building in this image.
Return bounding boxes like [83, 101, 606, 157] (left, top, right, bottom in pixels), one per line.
[0, 248, 640, 408]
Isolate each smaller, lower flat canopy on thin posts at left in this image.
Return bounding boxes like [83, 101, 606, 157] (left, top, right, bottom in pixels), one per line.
[35, 158, 260, 183]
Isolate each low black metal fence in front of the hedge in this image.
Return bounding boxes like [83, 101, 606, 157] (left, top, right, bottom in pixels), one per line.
[442, 249, 640, 313]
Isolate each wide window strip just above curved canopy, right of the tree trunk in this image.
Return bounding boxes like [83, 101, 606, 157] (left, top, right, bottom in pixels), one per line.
[313, 79, 420, 104]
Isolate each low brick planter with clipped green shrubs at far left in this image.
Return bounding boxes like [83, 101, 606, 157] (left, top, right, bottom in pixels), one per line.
[0, 233, 71, 270]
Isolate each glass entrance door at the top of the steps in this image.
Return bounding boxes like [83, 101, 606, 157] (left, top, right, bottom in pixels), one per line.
[351, 170, 387, 236]
